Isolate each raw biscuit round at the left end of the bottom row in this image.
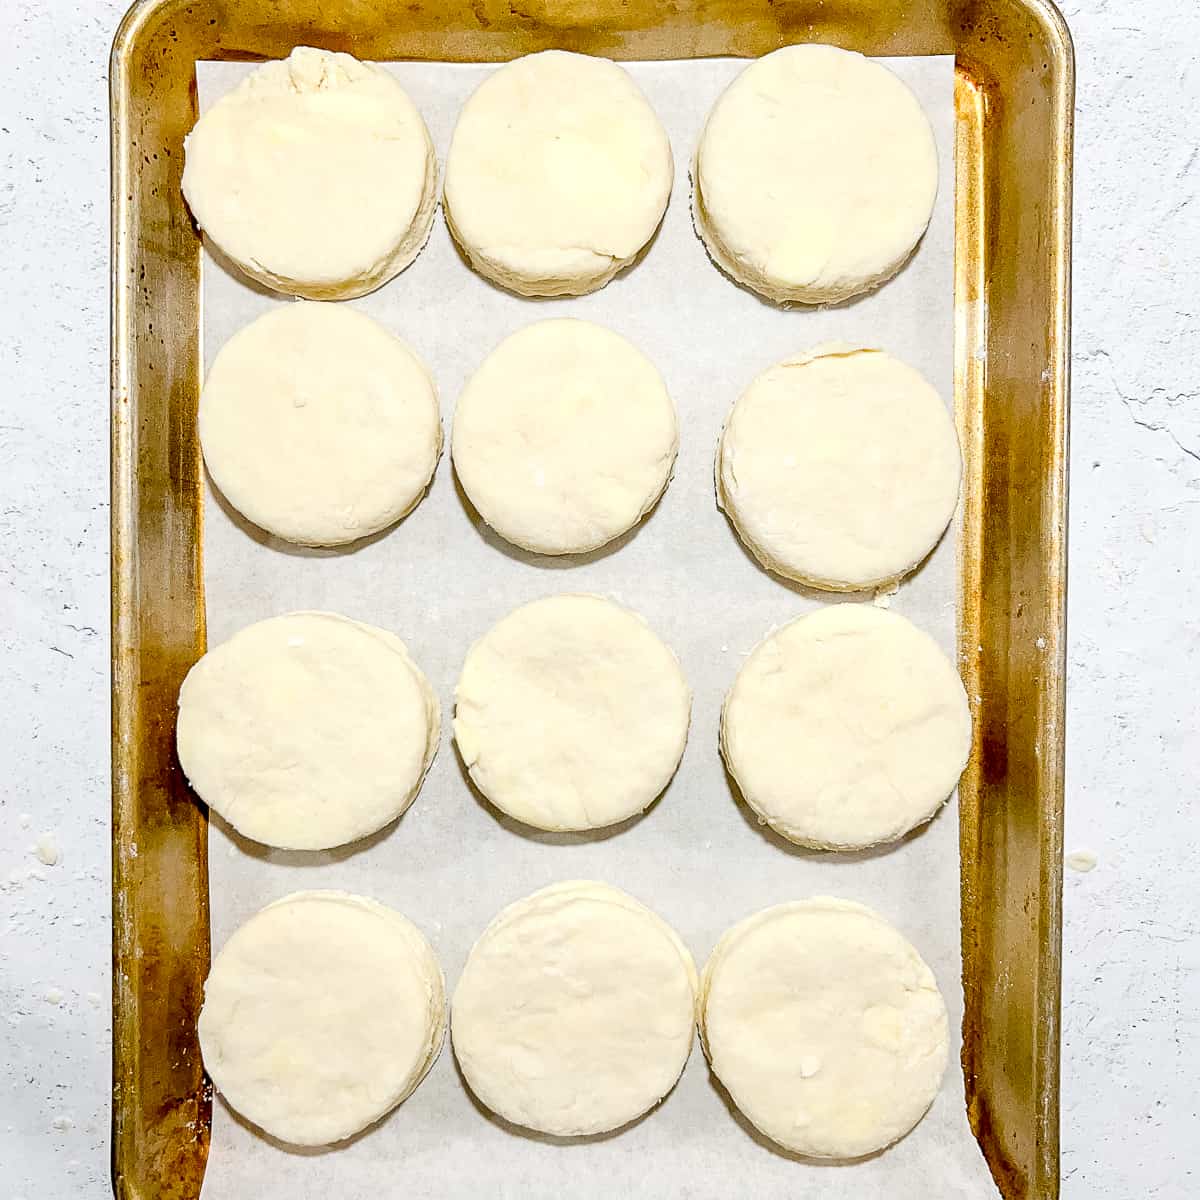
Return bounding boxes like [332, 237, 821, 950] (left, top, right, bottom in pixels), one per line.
[197, 892, 445, 1146]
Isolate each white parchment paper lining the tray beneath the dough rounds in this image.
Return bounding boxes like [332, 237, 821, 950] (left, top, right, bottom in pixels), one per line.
[197, 56, 996, 1200]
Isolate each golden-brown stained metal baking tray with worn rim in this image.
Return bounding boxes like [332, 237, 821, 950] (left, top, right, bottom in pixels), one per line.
[110, 0, 1074, 1200]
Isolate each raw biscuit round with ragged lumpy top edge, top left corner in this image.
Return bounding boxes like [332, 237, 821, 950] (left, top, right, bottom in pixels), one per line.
[182, 46, 437, 300]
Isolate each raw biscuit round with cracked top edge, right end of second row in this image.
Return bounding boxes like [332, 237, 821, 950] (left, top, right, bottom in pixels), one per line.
[716, 343, 961, 590]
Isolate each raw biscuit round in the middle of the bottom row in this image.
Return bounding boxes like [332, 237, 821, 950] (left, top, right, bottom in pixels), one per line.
[451, 881, 697, 1136]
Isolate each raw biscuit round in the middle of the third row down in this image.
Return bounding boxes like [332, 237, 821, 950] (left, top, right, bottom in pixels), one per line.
[454, 595, 691, 830]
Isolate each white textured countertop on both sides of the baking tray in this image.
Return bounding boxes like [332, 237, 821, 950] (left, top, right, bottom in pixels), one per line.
[0, 0, 1200, 1200]
